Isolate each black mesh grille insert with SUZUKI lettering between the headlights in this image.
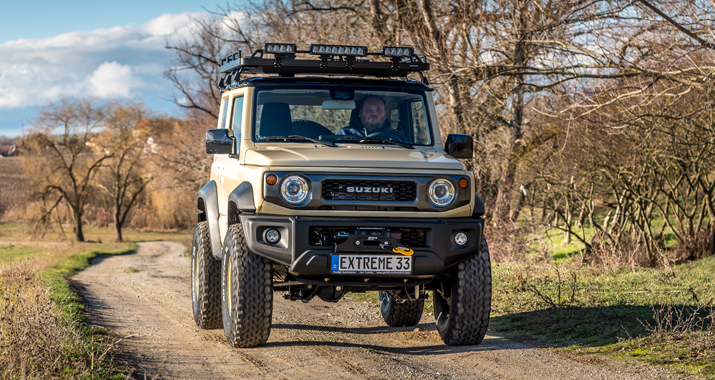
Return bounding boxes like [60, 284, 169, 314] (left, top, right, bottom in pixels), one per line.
[322, 179, 417, 202]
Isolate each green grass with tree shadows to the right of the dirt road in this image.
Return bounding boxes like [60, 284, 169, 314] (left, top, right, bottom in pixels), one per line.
[490, 256, 715, 378]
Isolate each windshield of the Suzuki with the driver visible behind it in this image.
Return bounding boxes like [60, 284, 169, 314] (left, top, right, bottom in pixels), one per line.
[254, 84, 433, 146]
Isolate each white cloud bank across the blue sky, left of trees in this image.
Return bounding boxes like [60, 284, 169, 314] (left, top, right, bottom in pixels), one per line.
[0, 13, 204, 110]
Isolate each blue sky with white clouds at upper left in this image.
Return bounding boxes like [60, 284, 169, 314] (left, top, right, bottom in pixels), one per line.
[0, 0, 225, 137]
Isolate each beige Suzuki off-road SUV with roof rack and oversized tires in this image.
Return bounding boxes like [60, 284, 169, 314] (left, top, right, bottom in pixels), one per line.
[191, 44, 491, 347]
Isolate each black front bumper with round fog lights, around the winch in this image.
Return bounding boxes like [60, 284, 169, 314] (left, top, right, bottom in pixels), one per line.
[240, 214, 484, 280]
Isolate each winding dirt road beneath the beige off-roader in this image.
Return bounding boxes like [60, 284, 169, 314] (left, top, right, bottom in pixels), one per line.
[73, 242, 684, 380]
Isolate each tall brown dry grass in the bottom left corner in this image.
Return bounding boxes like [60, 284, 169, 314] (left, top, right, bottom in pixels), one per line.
[0, 260, 117, 379]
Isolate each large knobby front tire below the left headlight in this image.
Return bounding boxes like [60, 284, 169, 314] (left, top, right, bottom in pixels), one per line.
[221, 224, 273, 348]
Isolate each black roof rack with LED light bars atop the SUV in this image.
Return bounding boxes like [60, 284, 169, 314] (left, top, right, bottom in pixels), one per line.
[218, 43, 429, 90]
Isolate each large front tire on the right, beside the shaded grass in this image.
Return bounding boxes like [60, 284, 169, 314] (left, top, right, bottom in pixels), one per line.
[434, 237, 492, 346]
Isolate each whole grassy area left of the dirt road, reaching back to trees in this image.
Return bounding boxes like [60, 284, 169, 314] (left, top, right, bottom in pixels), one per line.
[0, 224, 186, 379]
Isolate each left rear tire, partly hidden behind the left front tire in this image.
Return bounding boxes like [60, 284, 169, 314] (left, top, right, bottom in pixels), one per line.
[191, 222, 222, 329]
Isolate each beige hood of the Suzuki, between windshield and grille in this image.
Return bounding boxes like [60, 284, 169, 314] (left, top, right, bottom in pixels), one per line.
[245, 144, 464, 170]
